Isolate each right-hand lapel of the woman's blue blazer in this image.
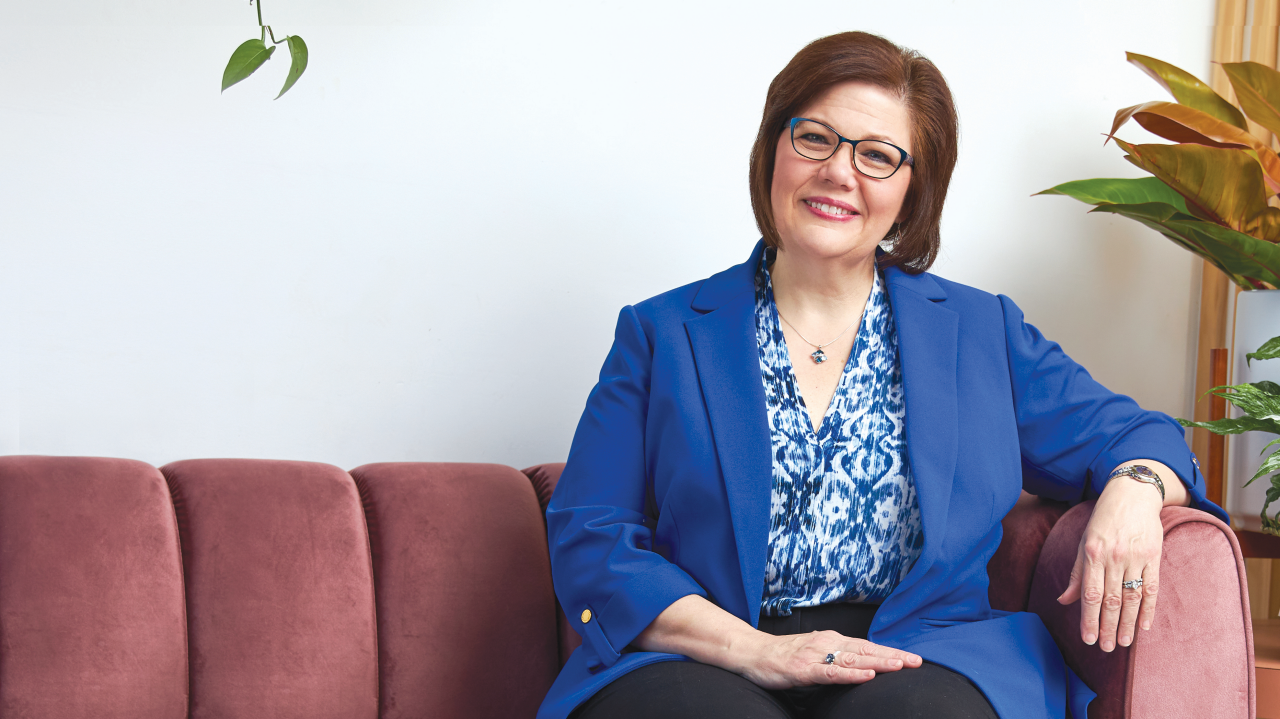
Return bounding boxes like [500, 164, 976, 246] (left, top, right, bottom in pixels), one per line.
[877, 267, 960, 601]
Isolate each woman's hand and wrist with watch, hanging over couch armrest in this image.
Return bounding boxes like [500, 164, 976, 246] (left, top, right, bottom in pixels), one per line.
[1057, 459, 1188, 651]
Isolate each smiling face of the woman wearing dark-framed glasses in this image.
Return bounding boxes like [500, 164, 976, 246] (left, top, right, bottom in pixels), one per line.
[771, 82, 913, 258]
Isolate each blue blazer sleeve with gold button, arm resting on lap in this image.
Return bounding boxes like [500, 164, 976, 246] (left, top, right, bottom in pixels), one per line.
[547, 306, 707, 668]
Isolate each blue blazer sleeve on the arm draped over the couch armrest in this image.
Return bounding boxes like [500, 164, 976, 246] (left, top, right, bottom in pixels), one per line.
[1000, 294, 1228, 522]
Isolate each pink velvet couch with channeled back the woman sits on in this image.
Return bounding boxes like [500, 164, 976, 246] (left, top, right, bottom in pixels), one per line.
[0, 457, 1254, 719]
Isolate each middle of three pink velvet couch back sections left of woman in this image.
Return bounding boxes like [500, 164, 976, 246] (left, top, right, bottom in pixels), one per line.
[161, 459, 378, 719]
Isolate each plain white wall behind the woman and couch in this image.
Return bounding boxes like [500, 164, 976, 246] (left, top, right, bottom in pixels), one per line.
[0, 0, 1213, 467]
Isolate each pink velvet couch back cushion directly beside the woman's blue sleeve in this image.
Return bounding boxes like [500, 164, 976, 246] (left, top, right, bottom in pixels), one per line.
[351, 463, 559, 719]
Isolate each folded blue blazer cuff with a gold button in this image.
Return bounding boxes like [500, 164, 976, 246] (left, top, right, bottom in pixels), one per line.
[573, 564, 707, 670]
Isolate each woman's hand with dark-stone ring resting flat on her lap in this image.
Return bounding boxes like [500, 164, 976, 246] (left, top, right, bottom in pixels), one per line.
[730, 624, 923, 690]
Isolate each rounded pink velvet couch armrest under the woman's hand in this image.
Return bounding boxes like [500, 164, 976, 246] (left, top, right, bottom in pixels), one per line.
[1028, 502, 1254, 719]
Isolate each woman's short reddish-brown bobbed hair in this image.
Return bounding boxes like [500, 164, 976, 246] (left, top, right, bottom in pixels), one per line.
[750, 32, 960, 274]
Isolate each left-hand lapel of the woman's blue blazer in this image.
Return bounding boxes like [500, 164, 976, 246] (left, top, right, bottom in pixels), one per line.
[685, 243, 773, 627]
